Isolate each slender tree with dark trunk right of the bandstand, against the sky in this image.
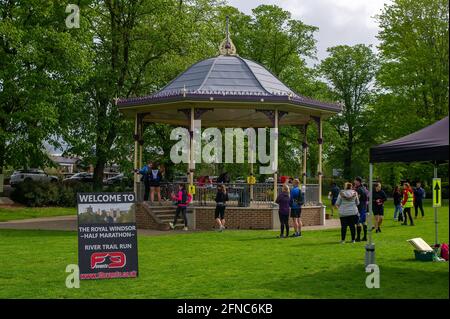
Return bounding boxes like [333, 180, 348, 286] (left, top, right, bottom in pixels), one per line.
[319, 44, 377, 178]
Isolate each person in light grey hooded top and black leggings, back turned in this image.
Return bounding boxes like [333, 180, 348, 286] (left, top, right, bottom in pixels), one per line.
[336, 183, 359, 244]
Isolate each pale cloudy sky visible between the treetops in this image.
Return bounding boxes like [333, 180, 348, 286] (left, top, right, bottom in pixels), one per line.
[228, 0, 390, 64]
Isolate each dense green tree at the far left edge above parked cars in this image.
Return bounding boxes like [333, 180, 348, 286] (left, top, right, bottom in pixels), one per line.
[0, 0, 89, 173]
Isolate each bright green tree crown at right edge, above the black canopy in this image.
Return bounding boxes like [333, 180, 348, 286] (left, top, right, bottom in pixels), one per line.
[377, 0, 449, 122]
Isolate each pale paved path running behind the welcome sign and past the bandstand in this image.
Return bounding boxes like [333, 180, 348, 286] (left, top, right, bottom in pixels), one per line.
[0, 216, 340, 236]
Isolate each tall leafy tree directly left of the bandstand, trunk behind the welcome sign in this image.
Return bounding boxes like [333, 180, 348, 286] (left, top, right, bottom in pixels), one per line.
[59, 0, 221, 188]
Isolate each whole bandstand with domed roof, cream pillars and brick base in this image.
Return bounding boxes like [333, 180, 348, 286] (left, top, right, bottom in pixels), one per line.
[116, 20, 341, 229]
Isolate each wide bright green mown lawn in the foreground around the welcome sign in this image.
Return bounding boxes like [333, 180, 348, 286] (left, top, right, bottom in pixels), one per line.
[0, 202, 449, 299]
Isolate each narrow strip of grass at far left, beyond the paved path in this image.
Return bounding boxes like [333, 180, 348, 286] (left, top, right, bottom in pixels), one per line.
[0, 207, 77, 222]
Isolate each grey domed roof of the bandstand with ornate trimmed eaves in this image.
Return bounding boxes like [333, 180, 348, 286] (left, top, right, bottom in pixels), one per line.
[116, 28, 341, 127]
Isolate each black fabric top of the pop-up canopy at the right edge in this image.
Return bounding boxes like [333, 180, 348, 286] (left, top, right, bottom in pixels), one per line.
[370, 116, 449, 163]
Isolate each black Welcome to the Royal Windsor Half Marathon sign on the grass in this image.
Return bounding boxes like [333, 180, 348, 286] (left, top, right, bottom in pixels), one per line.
[77, 193, 138, 279]
